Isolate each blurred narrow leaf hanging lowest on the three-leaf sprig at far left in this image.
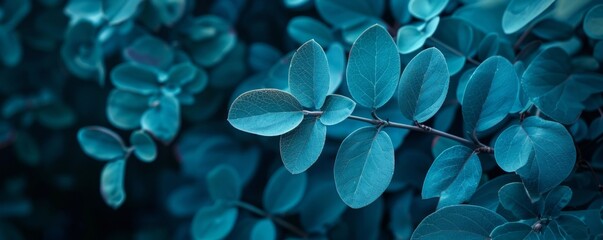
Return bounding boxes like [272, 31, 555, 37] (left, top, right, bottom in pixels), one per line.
[100, 159, 126, 209]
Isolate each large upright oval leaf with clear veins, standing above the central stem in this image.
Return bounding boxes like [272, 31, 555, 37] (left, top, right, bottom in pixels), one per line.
[346, 25, 400, 109]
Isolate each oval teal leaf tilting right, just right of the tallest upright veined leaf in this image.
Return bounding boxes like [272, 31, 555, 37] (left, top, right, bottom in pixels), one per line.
[398, 48, 450, 122]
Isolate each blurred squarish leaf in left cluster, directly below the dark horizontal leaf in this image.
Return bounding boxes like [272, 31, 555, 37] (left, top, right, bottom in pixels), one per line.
[107, 89, 149, 130]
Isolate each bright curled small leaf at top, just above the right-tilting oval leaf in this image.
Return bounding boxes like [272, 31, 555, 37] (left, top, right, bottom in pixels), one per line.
[396, 17, 440, 54]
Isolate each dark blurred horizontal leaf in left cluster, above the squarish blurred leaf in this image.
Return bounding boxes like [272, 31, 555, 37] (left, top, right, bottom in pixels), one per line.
[111, 63, 160, 95]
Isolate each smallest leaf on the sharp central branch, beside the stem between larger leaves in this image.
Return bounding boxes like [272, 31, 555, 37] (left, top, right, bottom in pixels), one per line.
[319, 94, 356, 126]
